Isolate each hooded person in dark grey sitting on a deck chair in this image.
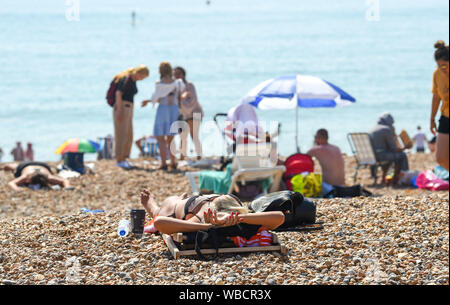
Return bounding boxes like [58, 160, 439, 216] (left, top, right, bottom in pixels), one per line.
[369, 112, 411, 185]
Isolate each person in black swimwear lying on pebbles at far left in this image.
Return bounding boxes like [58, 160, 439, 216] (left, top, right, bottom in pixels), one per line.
[2, 162, 74, 192]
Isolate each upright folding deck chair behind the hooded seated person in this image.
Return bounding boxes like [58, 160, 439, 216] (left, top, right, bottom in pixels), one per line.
[347, 132, 391, 184]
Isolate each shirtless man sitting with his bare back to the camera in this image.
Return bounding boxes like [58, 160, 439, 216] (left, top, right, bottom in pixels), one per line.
[307, 129, 345, 194]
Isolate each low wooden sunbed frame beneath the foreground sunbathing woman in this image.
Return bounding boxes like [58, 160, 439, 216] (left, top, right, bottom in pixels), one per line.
[162, 232, 287, 260]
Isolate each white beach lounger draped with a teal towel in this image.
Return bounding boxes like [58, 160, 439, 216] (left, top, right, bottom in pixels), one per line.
[186, 143, 286, 194]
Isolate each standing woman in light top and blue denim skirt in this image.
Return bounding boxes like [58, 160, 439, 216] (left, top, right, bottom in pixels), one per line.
[142, 62, 184, 170]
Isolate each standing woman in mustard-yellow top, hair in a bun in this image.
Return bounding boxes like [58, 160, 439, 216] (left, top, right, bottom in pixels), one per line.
[430, 40, 449, 170]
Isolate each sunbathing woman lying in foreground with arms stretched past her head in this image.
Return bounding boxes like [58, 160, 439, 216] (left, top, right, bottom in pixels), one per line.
[141, 190, 284, 234]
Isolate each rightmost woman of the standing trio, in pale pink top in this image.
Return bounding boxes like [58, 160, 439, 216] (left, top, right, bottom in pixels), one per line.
[174, 67, 203, 160]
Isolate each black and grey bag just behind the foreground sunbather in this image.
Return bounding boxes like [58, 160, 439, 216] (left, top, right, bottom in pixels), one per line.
[249, 191, 317, 230]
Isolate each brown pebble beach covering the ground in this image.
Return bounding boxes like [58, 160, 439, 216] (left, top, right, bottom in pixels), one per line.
[0, 154, 449, 285]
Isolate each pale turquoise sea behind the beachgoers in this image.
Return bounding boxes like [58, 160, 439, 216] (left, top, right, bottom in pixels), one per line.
[0, 0, 449, 161]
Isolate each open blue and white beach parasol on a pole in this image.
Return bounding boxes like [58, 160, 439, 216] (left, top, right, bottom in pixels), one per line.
[242, 75, 356, 151]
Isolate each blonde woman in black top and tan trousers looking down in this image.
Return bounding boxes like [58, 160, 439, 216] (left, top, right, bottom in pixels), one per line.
[113, 65, 150, 169]
